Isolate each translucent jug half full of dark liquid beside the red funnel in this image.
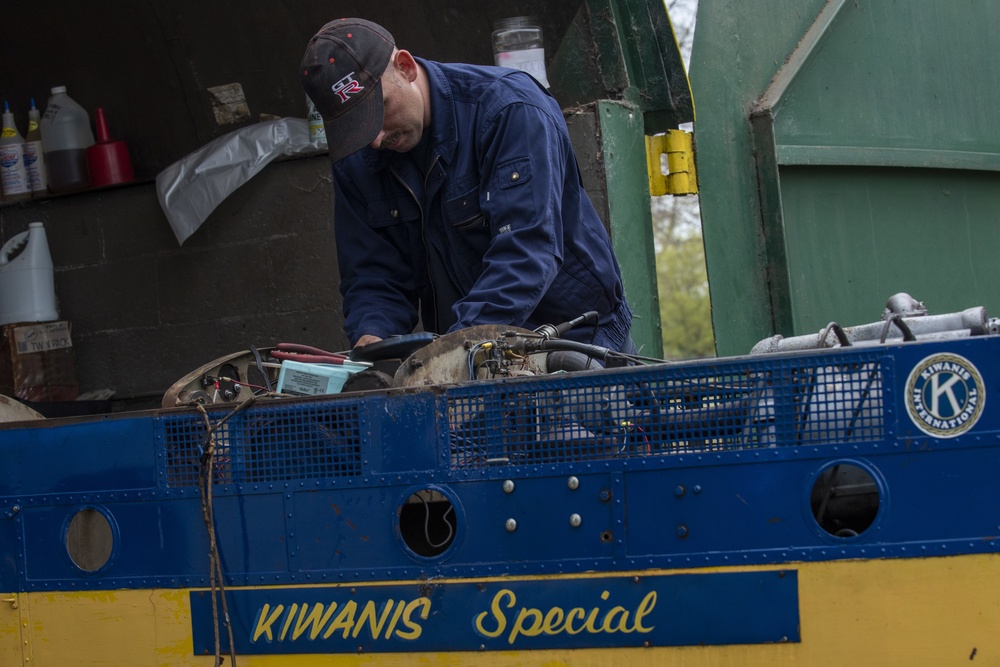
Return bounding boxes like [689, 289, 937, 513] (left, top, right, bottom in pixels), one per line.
[40, 86, 94, 192]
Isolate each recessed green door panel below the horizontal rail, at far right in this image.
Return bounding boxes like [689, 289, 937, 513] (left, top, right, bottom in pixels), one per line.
[781, 166, 1000, 333]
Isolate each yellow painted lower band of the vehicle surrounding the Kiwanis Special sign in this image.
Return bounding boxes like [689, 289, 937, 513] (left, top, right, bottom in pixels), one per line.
[7, 555, 1000, 667]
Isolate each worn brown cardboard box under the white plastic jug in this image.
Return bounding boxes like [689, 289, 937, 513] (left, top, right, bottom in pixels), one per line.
[0, 321, 80, 402]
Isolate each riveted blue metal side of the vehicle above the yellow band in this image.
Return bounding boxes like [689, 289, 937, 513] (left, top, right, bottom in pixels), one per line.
[0, 336, 1000, 591]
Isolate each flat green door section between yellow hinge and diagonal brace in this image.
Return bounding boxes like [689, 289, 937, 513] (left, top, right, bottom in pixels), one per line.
[690, 0, 824, 354]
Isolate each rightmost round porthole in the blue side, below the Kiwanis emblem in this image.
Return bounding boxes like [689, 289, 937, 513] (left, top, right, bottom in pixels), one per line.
[809, 463, 881, 538]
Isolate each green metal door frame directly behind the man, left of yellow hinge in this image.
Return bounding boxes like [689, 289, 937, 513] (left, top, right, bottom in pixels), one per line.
[547, 0, 694, 356]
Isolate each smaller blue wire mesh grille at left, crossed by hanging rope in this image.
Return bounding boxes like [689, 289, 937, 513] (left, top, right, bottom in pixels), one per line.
[164, 401, 363, 487]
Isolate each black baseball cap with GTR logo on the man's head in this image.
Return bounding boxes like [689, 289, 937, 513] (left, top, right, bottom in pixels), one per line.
[301, 19, 396, 162]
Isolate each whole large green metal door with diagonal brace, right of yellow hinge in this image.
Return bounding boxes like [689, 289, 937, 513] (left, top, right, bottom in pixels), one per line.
[691, 0, 1000, 354]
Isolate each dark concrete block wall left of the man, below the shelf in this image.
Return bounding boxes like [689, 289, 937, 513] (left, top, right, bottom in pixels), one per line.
[0, 156, 347, 410]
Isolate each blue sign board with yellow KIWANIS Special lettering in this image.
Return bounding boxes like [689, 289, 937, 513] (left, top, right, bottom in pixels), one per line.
[190, 570, 799, 655]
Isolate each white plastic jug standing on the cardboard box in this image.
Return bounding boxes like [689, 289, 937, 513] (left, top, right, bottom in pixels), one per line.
[0, 222, 59, 324]
